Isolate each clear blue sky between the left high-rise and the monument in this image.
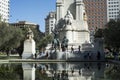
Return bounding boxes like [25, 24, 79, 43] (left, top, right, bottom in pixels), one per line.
[10, 0, 56, 32]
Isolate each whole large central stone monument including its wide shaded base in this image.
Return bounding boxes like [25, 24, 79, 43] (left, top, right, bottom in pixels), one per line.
[46, 0, 104, 60]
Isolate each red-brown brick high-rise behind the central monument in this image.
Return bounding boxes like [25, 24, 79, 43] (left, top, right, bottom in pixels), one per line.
[83, 0, 107, 30]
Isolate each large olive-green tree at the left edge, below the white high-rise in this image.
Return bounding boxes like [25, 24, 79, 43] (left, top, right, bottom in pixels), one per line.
[0, 22, 24, 55]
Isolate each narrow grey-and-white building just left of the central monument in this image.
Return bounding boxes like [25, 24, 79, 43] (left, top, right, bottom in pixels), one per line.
[45, 12, 56, 35]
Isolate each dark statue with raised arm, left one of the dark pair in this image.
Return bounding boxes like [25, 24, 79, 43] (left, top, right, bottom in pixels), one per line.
[51, 29, 59, 49]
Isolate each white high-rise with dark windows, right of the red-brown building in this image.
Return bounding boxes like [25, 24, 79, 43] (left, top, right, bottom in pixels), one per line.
[107, 0, 120, 21]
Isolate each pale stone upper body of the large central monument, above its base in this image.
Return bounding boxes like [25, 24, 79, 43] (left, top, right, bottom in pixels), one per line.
[55, 0, 90, 48]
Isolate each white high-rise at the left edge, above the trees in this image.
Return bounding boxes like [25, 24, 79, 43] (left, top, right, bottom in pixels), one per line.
[0, 0, 10, 22]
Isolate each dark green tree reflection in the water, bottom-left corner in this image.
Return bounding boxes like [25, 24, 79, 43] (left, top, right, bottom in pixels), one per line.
[0, 64, 22, 80]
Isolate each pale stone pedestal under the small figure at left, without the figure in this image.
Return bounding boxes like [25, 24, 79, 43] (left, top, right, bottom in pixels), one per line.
[22, 39, 36, 59]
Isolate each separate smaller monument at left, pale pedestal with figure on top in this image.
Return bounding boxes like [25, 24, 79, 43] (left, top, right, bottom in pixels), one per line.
[22, 28, 36, 59]
